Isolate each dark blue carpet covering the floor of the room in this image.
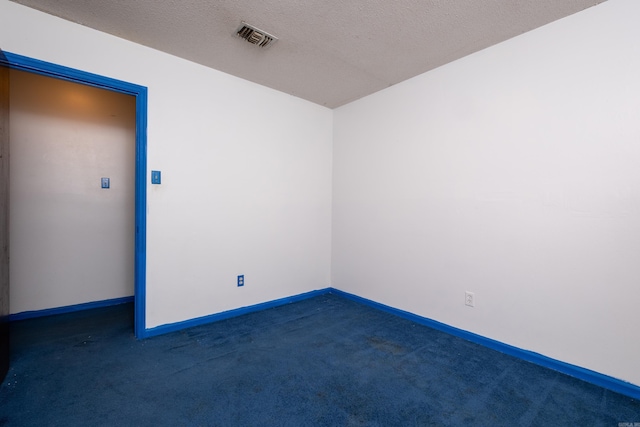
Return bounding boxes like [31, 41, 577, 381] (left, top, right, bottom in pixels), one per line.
[0, 295, 640, 427]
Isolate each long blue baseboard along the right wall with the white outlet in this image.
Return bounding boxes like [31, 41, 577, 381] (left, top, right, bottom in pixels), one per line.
[330, 288, 640, 399]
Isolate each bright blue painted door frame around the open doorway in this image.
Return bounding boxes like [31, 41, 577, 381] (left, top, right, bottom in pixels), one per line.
[0, 52, 147, 338]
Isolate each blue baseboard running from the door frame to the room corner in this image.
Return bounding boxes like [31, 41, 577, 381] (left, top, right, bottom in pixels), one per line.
[144, 288, 331, 338]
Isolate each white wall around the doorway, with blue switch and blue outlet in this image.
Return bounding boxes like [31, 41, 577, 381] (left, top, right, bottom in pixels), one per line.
[0, 0, 333, 327]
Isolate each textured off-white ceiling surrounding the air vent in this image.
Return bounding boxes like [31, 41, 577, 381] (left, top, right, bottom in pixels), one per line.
[15, 0, 604, 108]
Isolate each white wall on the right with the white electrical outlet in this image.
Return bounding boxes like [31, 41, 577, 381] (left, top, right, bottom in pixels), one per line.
[332, 0, 640, 384]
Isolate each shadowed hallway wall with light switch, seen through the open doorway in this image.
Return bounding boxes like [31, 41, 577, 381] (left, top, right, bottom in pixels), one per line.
[10, 70, 136, 313]
